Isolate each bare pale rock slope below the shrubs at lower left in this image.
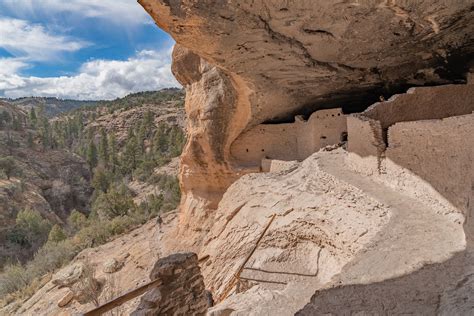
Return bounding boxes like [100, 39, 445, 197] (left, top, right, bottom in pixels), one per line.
[4, 213, 176, 315]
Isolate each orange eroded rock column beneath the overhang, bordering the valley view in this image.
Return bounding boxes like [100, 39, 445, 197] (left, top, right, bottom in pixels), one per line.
[172, 45, 254, 246]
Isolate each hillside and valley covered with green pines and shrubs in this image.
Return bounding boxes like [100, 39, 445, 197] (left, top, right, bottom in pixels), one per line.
[0, 89, 185, 299]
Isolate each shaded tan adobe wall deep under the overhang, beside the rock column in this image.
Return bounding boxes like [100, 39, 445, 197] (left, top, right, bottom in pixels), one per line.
[231, 109, 347, 166]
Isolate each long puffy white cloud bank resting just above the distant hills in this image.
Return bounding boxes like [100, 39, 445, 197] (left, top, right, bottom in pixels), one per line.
[0, 49, 179, 100]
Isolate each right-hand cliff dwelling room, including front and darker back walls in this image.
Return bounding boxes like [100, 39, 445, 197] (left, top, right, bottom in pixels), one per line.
[347, 85, 474, 211]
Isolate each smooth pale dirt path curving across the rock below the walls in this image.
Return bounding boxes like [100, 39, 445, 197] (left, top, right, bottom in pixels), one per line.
[319, 150, 465, 283]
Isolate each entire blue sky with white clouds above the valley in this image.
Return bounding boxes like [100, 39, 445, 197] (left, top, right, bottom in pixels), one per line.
[0, 0, 179, 100]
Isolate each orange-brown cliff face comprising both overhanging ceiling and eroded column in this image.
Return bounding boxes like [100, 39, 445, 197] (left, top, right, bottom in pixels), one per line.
[139, 0, 474, 244]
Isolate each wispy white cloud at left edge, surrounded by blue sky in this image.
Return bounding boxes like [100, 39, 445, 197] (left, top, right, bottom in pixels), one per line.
[0, 17, 87, 61]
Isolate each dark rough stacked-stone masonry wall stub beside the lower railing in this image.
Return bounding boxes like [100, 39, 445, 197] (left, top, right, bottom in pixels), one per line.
[132, 253, 208, 316]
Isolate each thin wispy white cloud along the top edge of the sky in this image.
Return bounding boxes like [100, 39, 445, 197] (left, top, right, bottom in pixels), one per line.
[1, 0, 150, 24]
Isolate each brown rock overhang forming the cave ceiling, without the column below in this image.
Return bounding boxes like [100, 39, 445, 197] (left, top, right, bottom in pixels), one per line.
[140, 0, 474, 125]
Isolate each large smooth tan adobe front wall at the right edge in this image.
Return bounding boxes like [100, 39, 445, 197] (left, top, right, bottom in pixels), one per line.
[385, 114, 474, 213]
